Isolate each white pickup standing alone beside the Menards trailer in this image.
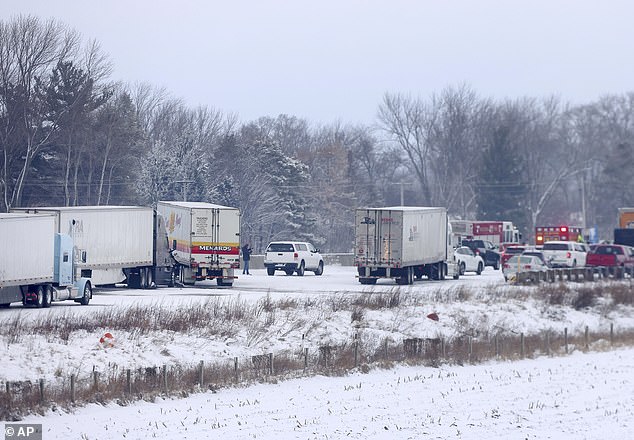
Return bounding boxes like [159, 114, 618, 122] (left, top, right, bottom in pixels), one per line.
[264, 241, 324, 277]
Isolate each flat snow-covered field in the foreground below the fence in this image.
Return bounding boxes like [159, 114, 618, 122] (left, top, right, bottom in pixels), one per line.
[23, 349, 634, 440]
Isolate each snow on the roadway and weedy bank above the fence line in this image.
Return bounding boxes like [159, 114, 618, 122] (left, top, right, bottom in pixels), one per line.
[0, 266, 634, 382]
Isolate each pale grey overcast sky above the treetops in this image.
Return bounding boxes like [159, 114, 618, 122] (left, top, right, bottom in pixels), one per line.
[0, 0, 634, 123]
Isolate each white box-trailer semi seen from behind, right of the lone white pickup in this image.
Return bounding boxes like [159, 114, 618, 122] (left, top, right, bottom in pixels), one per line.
[354, 206, 459, 285]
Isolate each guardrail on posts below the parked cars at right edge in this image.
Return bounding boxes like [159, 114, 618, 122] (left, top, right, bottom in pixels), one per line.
[509, 266, 634, 284]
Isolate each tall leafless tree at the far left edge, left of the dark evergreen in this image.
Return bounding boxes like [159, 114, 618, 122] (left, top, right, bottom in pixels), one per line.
[0, 16, 79, 209]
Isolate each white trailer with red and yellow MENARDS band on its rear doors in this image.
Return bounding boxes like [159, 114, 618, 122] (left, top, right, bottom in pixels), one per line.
[157, 201, 240, 286]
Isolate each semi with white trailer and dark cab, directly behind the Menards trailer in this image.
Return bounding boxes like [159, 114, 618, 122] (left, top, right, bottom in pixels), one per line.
[11, 206, 175, 289]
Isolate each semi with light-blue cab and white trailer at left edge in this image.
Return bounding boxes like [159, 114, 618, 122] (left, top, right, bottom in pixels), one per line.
[0, 213, 92, 308]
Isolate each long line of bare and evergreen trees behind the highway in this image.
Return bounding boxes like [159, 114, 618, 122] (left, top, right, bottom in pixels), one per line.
[0, 16, 634, 252]
